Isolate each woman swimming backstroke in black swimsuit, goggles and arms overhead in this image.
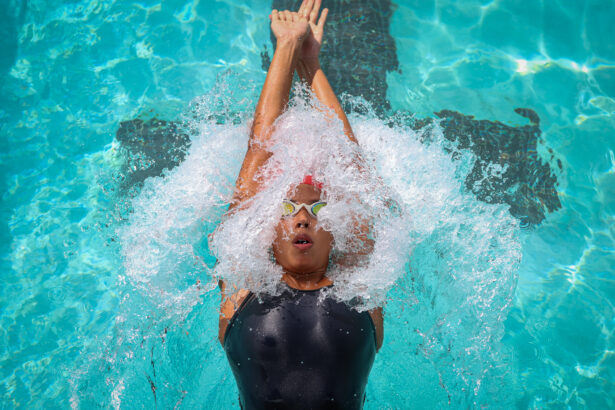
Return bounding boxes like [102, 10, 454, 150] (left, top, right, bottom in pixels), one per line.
[219, 0, 383, 409]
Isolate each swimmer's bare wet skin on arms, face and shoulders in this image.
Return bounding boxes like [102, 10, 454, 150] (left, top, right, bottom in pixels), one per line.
[218, 0, 383, 348]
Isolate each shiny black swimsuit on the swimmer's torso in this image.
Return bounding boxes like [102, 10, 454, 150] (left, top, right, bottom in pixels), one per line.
[224, 288, 376, 410]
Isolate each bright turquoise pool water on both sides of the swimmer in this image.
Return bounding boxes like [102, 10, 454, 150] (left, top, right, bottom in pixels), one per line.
[0, 0, 615, 409]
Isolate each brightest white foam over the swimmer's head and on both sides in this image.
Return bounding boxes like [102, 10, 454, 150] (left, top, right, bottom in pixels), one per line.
[120, 85, 513, 314]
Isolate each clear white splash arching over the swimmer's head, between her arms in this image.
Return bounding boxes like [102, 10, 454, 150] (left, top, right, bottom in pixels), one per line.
[212, 89, 412, 309]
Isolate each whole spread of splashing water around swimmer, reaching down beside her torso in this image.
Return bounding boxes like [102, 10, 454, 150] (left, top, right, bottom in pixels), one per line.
[77, 77, 520, 406]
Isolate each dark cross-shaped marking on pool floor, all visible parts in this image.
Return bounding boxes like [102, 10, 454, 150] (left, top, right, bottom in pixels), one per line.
[117, 0, 562, 225]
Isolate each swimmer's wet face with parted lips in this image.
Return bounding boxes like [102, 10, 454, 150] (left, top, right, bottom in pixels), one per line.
[273, 184, 333, 274]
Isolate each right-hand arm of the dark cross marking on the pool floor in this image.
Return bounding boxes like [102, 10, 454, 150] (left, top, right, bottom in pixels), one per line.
[410, 108, 562, 226]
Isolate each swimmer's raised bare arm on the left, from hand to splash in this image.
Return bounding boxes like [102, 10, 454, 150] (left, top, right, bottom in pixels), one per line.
[230, 9, 310, 209]
